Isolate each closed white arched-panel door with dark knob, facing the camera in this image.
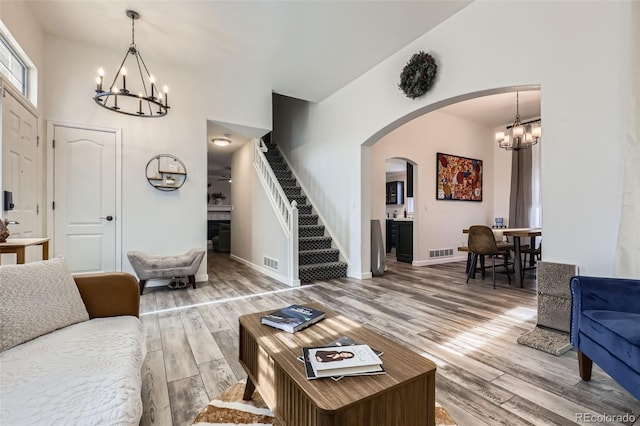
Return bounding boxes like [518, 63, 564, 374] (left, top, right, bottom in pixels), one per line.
[53, 125, 121, 273]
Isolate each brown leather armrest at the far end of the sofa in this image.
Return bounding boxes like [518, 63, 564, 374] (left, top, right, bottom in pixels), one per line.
[73, 272, 140, 318]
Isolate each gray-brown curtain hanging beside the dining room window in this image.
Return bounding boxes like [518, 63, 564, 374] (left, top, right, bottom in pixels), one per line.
[508, 149, 533, 228]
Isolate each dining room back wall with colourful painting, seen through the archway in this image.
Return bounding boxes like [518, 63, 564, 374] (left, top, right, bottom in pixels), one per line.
[371, 111, 498, 265]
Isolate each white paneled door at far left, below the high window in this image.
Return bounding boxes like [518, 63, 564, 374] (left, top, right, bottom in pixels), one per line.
[0, 83, 42, 238]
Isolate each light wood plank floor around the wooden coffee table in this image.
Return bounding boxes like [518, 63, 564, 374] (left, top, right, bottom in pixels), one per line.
[141, 252, 640, 426]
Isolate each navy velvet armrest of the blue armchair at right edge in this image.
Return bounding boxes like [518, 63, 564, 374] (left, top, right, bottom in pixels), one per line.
[570, 276, 640, 347]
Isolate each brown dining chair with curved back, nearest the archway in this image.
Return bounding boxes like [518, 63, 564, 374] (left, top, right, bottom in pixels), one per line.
[467, 225, 514, 289]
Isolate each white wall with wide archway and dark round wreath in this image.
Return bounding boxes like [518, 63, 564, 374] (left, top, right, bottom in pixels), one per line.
[274, 1, 630, 276]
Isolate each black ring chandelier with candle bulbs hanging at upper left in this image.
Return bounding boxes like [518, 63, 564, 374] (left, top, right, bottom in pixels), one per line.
[93, 10, 169, 118]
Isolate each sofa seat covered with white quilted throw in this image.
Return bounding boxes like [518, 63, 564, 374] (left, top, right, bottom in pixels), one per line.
[0, 316, 146, 426]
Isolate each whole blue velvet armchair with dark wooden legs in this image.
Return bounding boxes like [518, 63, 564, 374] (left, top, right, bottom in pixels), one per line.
[570, 276, 640, 399]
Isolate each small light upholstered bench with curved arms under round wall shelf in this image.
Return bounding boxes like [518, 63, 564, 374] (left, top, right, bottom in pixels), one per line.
[127, 249, 206, 294]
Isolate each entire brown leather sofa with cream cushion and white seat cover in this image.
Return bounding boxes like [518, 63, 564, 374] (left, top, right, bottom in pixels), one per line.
[0, 259, 146, 426]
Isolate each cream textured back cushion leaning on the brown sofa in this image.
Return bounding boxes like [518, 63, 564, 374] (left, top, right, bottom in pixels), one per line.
[0, 258, 89, 352]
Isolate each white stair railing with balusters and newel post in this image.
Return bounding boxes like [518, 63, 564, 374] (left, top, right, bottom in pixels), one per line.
[253, 139, 300, 286]
